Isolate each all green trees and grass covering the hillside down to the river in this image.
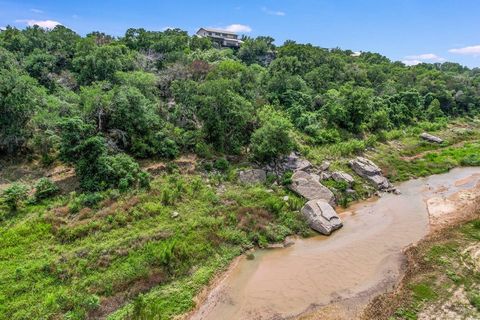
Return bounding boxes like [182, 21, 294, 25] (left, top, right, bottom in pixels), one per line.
[0, 26, 480, 319]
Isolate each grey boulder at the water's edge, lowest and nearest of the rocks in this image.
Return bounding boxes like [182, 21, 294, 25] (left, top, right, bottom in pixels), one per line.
[301, 199, 342, 235]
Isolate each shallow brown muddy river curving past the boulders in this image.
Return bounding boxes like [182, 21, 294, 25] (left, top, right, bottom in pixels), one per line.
[191, 168, 480, 320]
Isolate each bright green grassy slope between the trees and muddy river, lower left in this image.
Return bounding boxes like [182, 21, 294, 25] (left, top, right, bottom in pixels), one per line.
[0, 174, 310, 319]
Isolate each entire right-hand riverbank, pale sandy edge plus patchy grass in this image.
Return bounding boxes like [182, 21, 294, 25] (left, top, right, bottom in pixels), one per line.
[304, 174, 480, 320]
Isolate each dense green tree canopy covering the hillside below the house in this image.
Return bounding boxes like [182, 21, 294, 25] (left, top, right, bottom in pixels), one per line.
[0, 26, 480, 188]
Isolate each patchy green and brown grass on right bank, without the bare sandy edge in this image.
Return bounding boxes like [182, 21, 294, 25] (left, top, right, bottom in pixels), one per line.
[362, 215, 480, 320]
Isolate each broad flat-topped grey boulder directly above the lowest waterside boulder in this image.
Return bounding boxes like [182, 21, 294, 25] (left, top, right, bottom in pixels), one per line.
[290, 171, 335, 205]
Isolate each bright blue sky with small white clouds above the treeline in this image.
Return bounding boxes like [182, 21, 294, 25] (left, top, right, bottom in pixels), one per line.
[0, 0, 480, 67]
